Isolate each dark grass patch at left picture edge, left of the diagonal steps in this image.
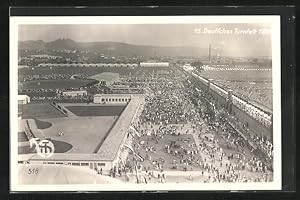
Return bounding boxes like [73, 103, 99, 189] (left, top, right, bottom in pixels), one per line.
[19, 103, 65, 119]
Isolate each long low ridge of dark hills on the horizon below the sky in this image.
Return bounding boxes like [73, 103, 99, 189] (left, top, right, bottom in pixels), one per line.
[19, 39, 208, 56]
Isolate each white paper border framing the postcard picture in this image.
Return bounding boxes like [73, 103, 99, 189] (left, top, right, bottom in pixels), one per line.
[9, 15, 282, 191]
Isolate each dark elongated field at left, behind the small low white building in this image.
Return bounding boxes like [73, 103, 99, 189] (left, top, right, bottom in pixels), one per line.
[23, 79, 95, 89]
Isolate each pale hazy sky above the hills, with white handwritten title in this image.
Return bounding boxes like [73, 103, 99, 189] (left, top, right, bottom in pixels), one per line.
[18, 24, 272, 56]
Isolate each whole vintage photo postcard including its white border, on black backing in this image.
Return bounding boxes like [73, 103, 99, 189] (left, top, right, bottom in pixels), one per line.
[9, 16, 281, 191]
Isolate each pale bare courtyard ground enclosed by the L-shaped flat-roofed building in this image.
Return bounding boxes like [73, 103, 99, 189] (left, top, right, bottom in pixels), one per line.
[42, 116, 116, 153]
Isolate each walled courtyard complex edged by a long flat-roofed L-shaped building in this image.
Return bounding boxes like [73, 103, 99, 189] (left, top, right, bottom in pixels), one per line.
[19, 95, 142, 171]
